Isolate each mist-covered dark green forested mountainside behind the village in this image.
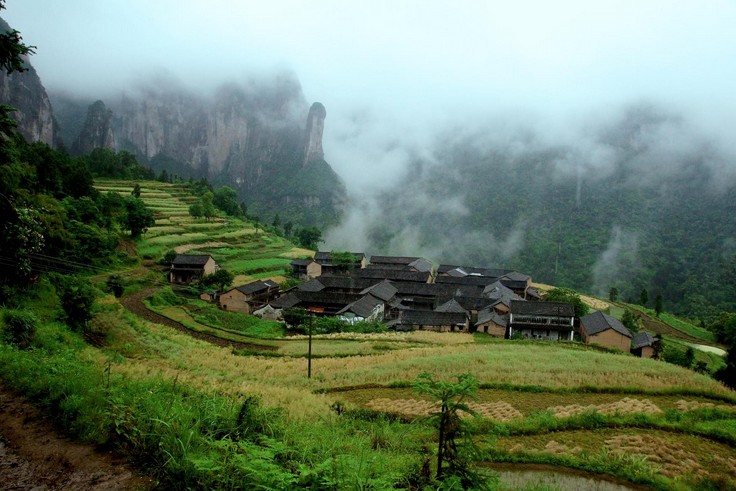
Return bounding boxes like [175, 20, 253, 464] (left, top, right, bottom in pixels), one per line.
[358, 106, 736, 321]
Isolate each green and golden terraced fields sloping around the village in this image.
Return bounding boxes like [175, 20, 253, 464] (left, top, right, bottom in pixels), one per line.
[0, 179, 736, 490]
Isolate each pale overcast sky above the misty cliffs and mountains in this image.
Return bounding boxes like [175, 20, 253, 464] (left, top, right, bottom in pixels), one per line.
[2, 0, 736, 189]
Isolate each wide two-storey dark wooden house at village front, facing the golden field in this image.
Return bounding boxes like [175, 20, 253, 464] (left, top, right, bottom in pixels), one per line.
[508, 300, 575, 341]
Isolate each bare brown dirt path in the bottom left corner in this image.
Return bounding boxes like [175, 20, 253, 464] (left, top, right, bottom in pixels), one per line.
[0, 384, 155, 491]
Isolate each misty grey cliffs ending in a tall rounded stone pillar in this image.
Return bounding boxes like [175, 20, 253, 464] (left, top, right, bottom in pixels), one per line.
[56, 74, 346, 226]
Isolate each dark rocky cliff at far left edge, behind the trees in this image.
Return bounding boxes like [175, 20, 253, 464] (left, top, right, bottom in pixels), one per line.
[0, 19, 60, 146]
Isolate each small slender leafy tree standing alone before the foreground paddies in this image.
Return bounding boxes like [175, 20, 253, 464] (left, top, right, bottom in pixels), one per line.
[413, 373, 487, 489]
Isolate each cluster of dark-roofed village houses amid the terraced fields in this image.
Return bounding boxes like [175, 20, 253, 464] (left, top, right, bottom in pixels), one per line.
[169, 252, 657, 358]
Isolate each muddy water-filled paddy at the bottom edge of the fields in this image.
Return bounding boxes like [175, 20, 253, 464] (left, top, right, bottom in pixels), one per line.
[493, 465, 646, 491]
